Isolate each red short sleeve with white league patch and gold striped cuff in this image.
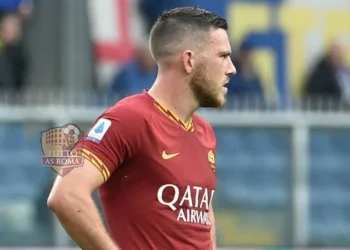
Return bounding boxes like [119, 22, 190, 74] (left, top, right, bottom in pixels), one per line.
[75, 106, 145, 181]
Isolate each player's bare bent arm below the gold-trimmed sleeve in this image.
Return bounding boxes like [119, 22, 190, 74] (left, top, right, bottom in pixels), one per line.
[48, 160, 119, 250]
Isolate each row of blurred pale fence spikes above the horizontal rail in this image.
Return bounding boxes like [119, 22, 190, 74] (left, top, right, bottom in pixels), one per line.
[0, 91, 350, 112]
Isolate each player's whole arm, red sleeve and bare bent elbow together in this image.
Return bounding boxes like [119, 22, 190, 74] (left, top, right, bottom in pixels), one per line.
[48, 107, 145, 250]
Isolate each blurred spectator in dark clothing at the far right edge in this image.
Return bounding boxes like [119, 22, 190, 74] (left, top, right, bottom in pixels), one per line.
[305, 40, 350, 104]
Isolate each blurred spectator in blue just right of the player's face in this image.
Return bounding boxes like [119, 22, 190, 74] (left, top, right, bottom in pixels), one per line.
[227, 44, 264, 103]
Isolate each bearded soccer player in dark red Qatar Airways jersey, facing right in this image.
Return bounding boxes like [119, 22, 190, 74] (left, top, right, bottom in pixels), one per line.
[48, 7, 236, 250]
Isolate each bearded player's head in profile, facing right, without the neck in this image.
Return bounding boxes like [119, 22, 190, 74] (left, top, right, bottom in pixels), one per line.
[150, 7, 236, 107]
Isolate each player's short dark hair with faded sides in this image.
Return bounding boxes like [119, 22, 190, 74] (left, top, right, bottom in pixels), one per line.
[149, 7, 228, 61]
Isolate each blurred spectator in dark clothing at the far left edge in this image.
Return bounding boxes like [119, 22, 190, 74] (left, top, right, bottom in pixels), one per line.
[0, 13, 27, 92]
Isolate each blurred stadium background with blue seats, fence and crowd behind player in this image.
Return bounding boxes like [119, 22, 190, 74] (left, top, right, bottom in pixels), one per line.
[0, 0, 350, 249]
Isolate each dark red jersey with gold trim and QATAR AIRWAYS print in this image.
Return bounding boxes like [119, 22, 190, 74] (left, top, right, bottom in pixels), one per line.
[75, 91, 216, 250]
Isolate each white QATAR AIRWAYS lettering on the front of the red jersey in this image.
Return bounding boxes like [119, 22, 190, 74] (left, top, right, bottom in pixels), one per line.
[157, 184, 215, 225]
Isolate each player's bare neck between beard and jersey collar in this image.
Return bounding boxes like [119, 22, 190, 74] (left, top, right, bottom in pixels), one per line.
[148, 76, 198, 124]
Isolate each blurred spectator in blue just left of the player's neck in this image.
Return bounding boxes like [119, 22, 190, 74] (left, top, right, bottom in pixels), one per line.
[111, 43, 157, 97]
